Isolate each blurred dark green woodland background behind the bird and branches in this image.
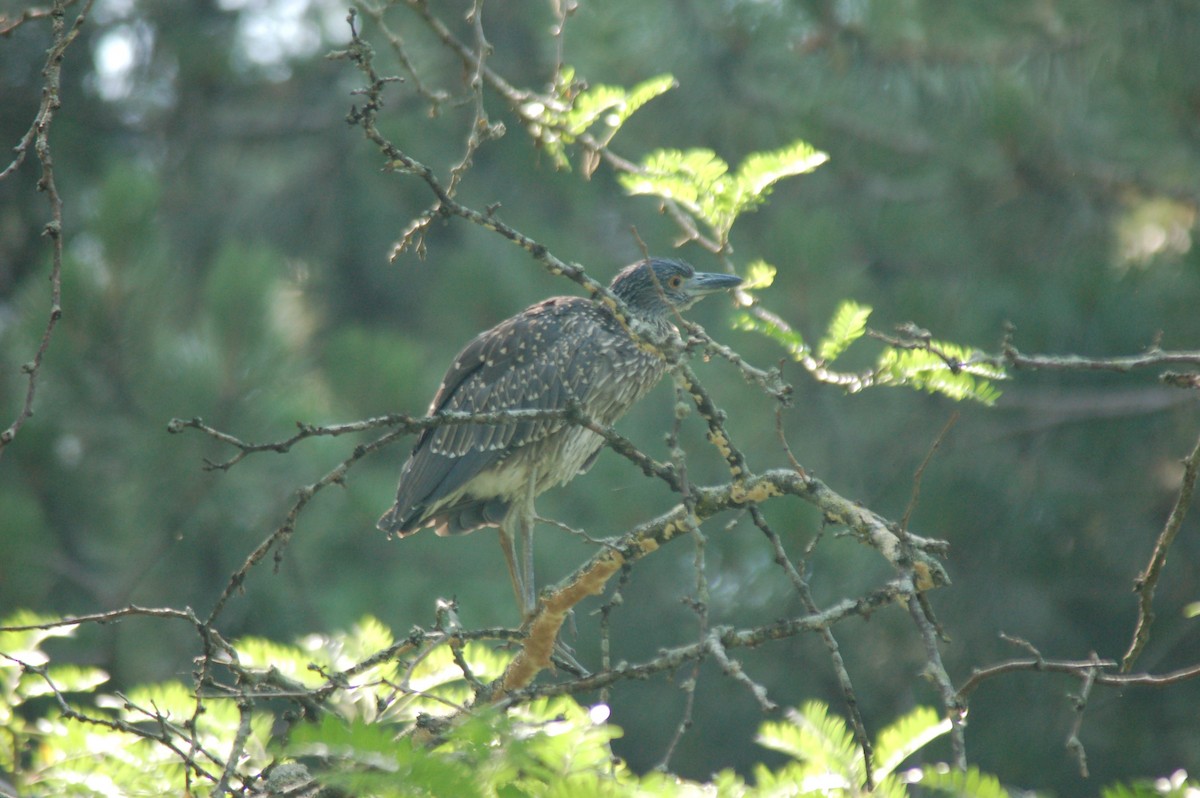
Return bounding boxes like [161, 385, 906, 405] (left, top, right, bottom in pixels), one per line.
[0, 0, 1200, 796]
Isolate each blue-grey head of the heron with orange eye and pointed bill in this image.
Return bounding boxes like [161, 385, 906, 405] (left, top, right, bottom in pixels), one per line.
[610, 258, 742, 319]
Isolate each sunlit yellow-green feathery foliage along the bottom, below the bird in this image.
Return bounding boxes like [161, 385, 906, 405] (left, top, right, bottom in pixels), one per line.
[0, 613, 1196, 798]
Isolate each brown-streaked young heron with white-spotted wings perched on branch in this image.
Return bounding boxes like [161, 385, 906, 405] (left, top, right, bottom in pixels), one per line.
[379, 258, 742, 618]
